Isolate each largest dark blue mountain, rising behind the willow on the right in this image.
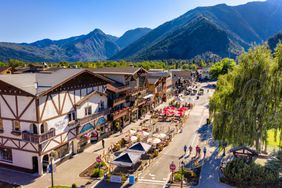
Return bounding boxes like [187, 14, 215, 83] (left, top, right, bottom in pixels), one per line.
[112, 0, 282, 59]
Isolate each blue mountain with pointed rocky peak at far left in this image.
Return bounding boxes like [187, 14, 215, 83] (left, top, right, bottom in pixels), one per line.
[0, 29, 120, 62]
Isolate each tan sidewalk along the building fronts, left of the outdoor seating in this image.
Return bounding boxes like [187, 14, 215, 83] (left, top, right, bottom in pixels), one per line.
[0, 99, 174, 188]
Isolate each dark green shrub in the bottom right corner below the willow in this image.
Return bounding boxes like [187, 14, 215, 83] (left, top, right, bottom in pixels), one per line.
[223, 159, 279, 186]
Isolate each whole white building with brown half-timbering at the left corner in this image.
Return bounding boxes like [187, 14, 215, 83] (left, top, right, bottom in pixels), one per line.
[0, 69, 111, 175]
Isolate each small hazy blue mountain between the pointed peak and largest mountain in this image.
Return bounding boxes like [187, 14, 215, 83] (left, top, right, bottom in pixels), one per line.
[116, 27, 151, 48]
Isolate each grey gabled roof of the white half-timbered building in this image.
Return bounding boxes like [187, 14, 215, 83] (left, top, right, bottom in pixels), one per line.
[0, 69, 112, 96]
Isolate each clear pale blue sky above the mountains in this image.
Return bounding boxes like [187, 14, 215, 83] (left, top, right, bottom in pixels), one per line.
[0, 0, 264, 42]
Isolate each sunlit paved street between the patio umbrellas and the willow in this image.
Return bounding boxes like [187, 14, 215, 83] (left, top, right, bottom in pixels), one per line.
[133, 83, 211, 188]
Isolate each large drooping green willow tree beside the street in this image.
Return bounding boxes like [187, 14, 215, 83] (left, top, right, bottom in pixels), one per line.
[210, 45, 282, 151]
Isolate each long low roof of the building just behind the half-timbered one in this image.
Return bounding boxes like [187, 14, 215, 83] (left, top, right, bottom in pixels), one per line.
[90, 67, 147, 75]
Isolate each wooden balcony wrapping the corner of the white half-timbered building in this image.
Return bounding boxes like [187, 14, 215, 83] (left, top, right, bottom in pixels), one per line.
[22, 129, 56, 144]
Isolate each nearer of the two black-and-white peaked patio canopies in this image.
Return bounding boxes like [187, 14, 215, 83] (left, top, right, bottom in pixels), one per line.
[111, 152, 141, 167]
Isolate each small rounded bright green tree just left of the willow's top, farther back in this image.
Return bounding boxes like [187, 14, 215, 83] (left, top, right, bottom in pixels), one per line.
[210, 58, 236, 79]
